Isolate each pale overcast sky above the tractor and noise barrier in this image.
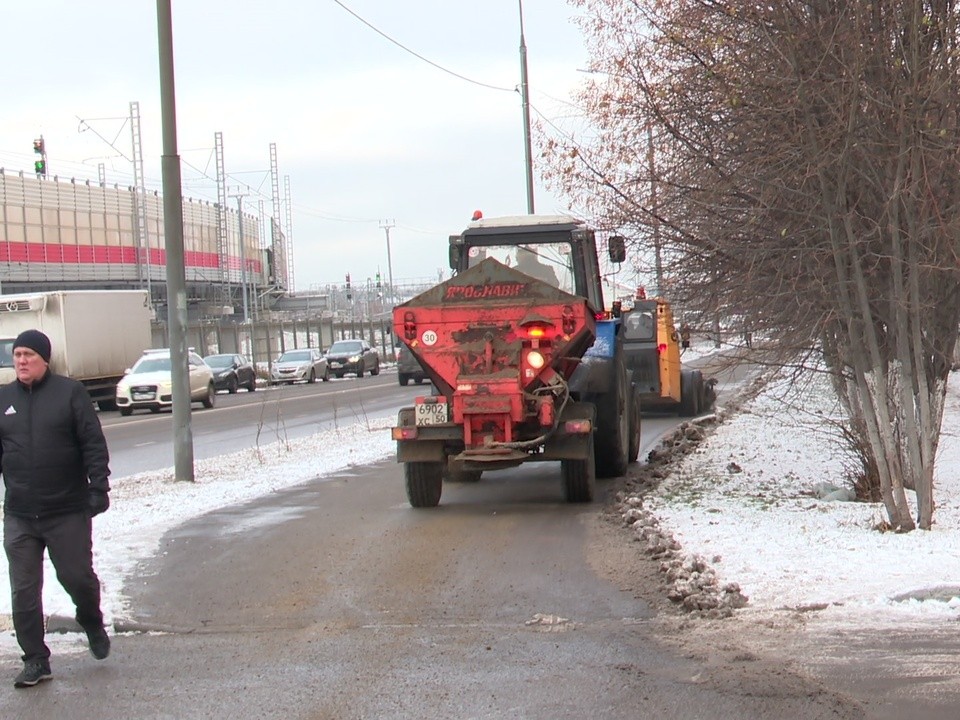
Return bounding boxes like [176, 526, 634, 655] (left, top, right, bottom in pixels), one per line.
[0, 0, 587, 290]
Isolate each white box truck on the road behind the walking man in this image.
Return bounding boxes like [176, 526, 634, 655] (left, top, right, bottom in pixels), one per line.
[0, 290, 153, 410]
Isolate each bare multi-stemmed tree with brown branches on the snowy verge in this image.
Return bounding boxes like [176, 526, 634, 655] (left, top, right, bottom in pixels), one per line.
[542, 0, 960, 531]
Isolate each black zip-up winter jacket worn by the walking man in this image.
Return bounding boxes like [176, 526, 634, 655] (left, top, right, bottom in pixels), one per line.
[0, 370, 110, 518]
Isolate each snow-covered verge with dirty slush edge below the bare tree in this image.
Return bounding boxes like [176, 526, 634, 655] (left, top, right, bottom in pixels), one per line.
[621, 366, 960, 622]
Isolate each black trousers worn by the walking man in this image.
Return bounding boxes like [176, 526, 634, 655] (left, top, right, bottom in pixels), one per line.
[3, 512, 103, 662]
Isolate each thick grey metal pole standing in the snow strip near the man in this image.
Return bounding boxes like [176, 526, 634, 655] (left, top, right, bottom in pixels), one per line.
[157, 0, 194, 482]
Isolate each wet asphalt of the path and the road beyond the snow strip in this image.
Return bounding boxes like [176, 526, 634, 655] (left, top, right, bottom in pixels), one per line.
[0, 358, 950, 720]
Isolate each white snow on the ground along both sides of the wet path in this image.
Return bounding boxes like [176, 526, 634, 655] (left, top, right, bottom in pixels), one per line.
[0, 348, 960, 646]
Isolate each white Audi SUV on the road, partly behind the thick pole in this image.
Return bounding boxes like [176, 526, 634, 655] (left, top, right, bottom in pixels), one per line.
[117, 348, 217, 415]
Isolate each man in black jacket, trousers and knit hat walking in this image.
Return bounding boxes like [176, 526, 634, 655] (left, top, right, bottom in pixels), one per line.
[0, 330, 110, 688]
